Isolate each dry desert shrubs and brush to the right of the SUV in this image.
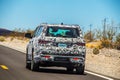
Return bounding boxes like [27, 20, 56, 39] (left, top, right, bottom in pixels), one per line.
[84, 19, 120, 50]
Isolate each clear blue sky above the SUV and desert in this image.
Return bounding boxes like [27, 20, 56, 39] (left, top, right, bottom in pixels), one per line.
[0, 0, 120, 30]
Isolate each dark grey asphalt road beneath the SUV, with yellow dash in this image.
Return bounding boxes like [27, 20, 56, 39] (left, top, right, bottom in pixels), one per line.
[0, 46, 110, 80]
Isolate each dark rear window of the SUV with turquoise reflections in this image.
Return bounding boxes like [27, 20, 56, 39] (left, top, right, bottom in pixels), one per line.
[46, 26, 79, 38]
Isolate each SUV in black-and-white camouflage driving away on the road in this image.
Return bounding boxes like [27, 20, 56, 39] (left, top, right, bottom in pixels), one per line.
[25, 24, 86, 74]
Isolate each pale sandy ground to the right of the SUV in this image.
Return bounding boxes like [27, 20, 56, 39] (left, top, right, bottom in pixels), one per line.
[86, 48, 120, 79]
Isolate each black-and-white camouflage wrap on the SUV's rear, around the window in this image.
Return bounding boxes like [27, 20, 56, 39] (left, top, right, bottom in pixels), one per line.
[34, 24, 86, 55]
